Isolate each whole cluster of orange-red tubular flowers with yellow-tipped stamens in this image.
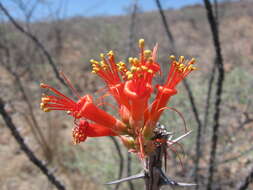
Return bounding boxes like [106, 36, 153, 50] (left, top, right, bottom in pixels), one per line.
[41, 39, 196, 158]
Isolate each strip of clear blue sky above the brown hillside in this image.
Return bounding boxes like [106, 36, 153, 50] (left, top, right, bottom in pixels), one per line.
[2, 0, 202, 19]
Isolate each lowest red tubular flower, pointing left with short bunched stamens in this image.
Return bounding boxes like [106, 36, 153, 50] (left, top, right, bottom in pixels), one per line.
[72, 120, 117, 144]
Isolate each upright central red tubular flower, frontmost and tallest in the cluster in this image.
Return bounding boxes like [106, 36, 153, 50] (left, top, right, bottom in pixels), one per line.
[124, 39, 160, 129]
